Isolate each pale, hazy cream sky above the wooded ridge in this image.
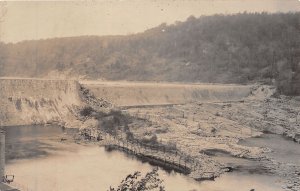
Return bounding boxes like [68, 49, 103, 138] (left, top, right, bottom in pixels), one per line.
[0, 0, 300, 43]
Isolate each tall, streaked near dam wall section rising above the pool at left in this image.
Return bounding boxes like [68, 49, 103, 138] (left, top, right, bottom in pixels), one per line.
[0, 78, 82, 126]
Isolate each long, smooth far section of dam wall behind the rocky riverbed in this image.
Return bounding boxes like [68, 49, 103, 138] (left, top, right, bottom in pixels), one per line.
[80, 81, 253, 106]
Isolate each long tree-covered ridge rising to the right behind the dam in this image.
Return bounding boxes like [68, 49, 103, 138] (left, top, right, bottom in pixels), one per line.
[0, 12, 300, 95]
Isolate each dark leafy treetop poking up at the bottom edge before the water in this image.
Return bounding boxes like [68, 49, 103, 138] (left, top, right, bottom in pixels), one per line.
[109, 168, 165, 191]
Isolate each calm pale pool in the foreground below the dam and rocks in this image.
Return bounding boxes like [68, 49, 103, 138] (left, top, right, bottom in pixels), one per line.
[6, 126, 281, 191]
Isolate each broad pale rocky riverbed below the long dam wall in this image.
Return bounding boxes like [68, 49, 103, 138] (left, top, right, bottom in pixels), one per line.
[99, 86, 300, 190]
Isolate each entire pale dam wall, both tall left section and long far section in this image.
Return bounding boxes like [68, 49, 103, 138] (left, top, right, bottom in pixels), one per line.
[0, 78, 253, 127]
